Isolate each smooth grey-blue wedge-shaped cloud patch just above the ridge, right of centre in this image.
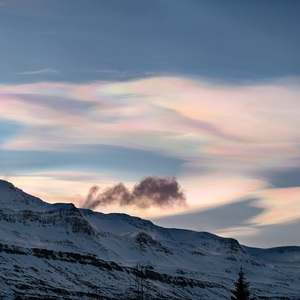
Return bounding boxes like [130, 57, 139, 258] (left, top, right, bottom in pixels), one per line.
[152, 198, 264, 232]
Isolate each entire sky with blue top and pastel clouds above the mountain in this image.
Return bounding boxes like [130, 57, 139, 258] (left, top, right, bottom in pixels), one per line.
[0, 0, 300, 247]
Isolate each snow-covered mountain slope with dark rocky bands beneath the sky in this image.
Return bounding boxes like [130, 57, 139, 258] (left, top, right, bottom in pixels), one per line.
[0, 180, 300, 300]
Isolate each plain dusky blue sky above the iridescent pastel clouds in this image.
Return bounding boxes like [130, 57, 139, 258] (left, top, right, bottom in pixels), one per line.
[0, 0, 300, 82]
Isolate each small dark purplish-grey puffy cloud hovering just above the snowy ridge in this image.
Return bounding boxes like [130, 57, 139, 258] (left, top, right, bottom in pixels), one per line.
[82, 177, 186, 209]
